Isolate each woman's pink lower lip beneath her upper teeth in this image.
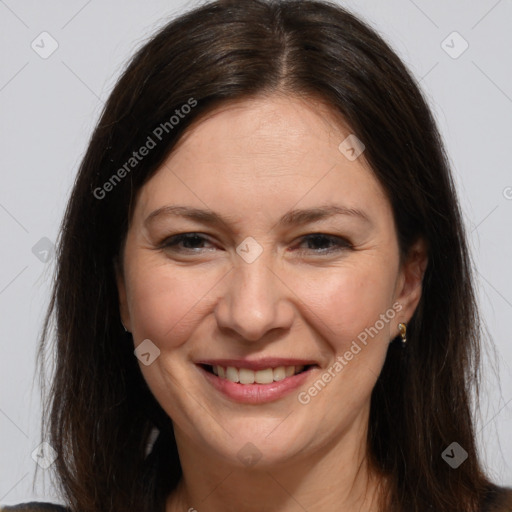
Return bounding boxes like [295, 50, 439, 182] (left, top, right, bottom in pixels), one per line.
[197, 365, 313, 404]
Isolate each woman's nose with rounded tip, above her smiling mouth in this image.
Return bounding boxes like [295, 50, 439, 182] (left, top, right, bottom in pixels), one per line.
[215, 257, 294, 342]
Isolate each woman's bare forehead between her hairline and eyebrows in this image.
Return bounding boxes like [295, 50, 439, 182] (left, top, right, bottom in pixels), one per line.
[136, 95, 390, 230]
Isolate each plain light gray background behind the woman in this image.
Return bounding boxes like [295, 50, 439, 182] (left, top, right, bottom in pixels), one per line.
[0, 0, 512, 504]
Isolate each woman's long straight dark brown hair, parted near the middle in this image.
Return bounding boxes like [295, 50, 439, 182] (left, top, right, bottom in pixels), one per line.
[39, 0, 496, 512]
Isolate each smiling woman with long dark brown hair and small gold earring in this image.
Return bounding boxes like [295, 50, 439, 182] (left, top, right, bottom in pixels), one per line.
[5, 0, 512, 512]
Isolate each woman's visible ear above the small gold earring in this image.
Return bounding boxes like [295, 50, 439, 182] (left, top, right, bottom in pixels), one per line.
[395, 238, 428, 322]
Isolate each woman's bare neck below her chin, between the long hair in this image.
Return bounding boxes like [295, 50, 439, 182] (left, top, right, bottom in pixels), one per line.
[166, 414, 384, 512]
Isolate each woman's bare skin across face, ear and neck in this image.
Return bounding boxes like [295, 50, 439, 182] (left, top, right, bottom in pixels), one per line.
[117, 94, 427, 512]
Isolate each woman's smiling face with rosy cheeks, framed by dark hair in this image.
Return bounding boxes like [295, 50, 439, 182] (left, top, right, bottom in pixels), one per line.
[117, 96, 425, 465]
